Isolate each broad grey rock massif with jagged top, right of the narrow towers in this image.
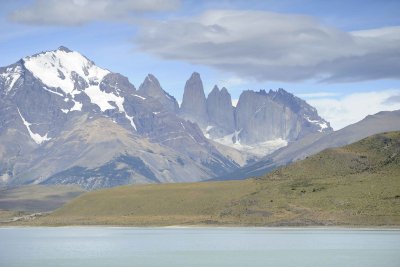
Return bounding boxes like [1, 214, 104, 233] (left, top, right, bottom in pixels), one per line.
[236, 89, 332, 144]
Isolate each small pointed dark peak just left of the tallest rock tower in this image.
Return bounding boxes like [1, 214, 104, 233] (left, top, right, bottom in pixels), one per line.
[138, 74, 179, 113]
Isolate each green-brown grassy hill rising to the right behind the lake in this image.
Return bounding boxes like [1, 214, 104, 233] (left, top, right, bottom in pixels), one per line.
[25, 132, 400, 226]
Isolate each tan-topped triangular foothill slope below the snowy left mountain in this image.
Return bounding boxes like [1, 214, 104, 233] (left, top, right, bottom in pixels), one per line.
[11, 117, 216, 189]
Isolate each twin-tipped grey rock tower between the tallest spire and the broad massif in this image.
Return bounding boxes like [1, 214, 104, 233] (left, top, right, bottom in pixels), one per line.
[207, 86, 235, 137]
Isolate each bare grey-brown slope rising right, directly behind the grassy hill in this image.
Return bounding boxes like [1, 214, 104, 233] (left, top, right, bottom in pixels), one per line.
[216, 110, 400, 180]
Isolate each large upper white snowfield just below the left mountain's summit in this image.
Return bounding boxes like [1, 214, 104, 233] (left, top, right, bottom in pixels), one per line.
[23, 46, 110, 94]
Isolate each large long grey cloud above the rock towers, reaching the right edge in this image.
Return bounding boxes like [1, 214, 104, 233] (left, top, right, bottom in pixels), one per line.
[136, 10, 400, 82]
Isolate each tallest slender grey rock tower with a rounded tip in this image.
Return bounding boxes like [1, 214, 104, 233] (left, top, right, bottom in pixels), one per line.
[179, 72, 208, 127]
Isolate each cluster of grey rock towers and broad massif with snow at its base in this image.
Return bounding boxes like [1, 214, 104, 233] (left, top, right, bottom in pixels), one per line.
[179, 73, 332, 155]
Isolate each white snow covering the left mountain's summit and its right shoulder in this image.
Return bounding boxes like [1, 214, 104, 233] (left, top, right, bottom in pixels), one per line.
[14, 46, 136, 133]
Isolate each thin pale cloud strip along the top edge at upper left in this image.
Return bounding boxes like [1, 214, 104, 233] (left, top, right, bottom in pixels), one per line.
[9, 0, 180, 25]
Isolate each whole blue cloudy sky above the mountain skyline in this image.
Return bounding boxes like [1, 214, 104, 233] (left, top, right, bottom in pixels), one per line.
[0, 0, 400, 130]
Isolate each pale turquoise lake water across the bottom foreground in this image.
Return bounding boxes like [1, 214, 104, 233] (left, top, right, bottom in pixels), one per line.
[0, 227, 400, 267]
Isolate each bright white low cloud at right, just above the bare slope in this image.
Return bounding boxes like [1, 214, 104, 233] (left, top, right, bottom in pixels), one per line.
[307, 90, 400, 130]
